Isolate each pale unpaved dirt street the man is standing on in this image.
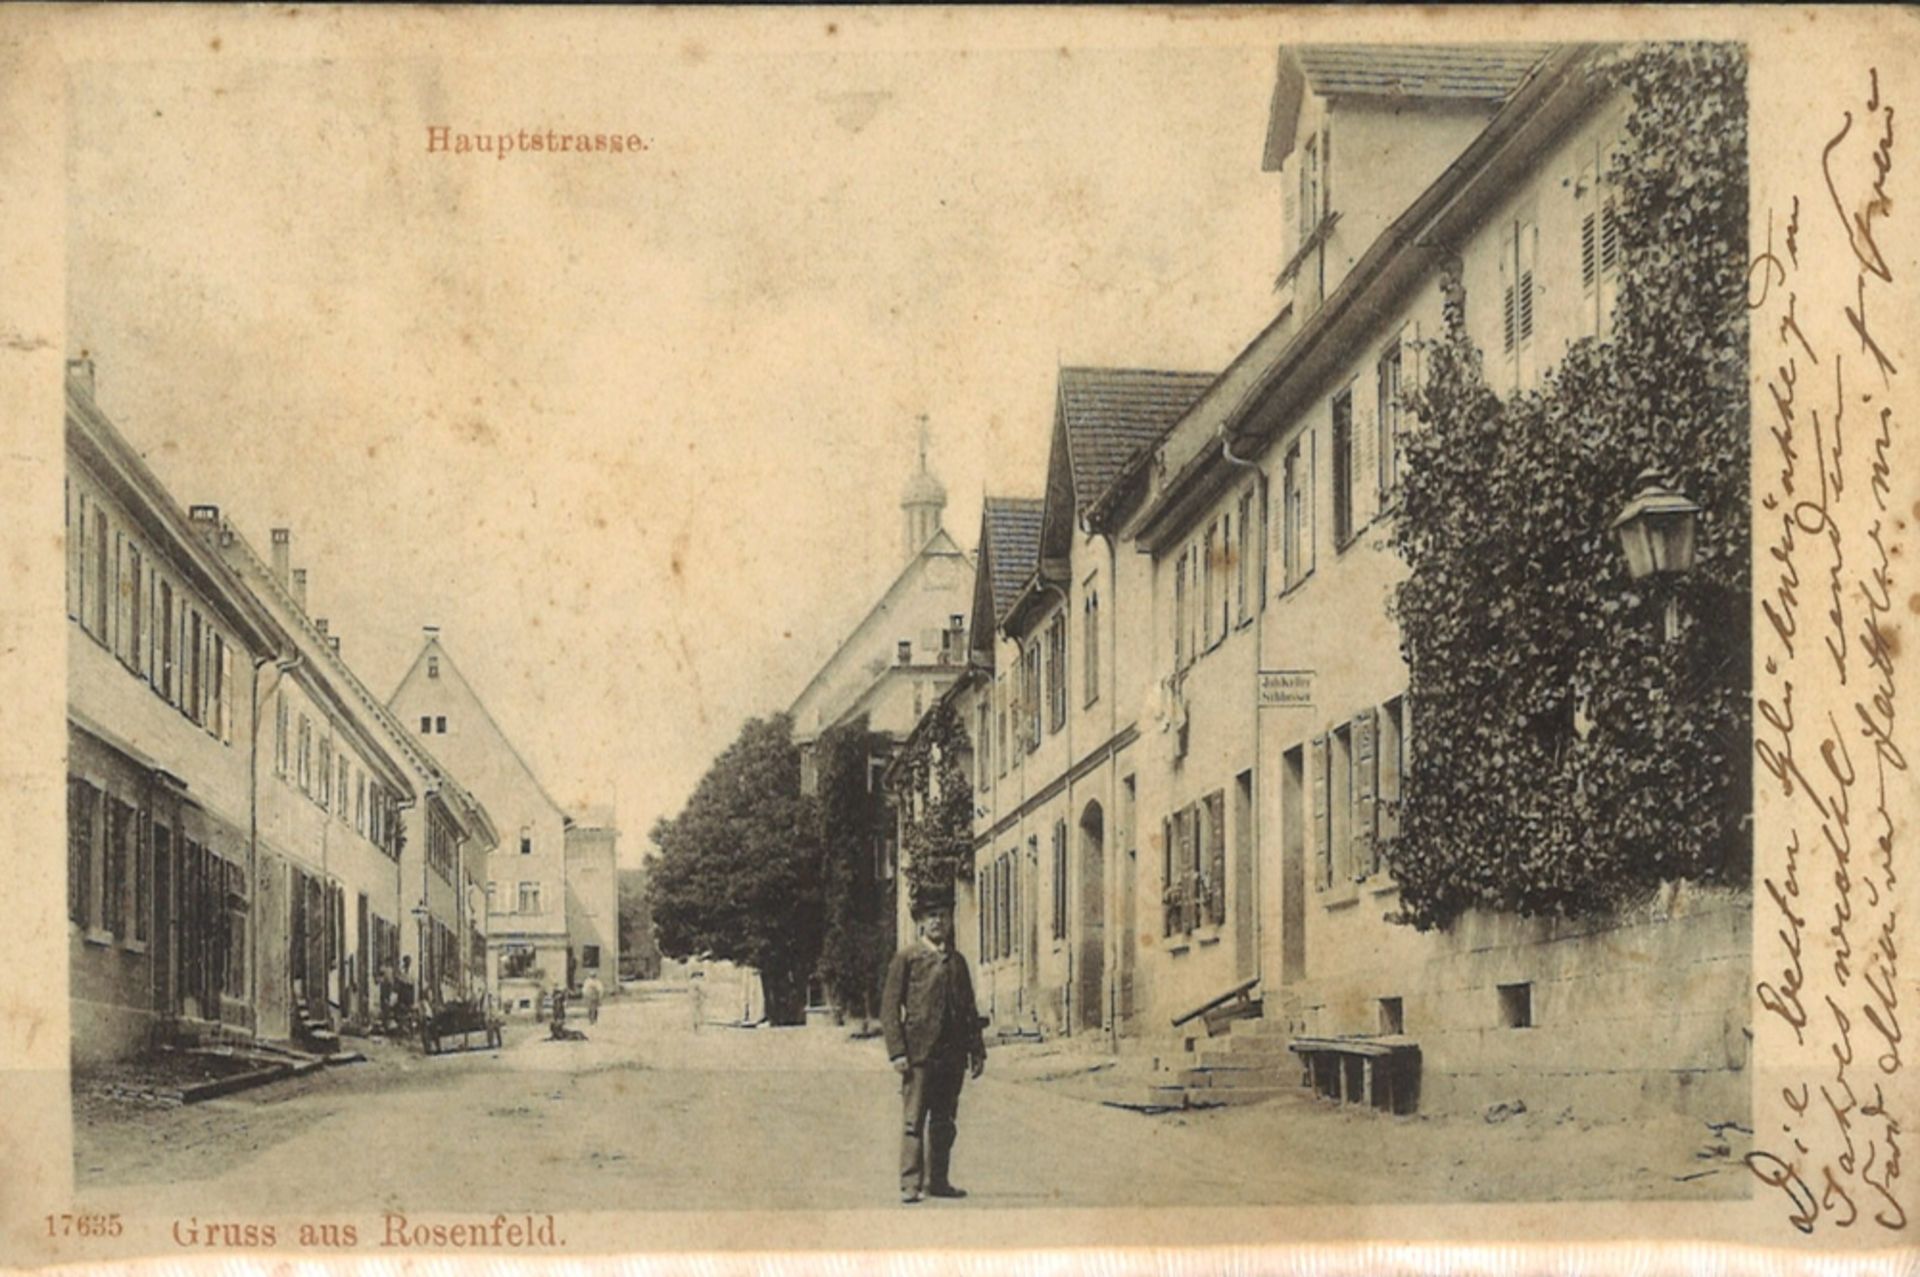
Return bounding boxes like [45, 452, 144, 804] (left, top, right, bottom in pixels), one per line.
[75, 989, 1747, 1216]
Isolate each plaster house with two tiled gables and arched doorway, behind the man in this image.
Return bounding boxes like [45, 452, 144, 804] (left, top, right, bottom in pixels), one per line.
[972, 369, 1213, 1033]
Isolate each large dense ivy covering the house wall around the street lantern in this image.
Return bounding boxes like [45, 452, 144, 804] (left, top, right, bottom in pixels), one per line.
[1386, 44, 1751, 929]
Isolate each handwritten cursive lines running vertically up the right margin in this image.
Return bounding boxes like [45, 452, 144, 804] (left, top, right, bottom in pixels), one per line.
[1747, 71, 1914, 1233]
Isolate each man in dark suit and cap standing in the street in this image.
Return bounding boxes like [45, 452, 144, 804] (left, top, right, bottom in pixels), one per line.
[879, 901, 987, 1202]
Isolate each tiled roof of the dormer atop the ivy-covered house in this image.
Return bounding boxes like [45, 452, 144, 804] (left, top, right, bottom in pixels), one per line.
[1261, 44, 1553, 171]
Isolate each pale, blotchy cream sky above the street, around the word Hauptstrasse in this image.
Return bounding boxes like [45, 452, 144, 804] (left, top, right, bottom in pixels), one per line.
[67, 10, 1281, 862]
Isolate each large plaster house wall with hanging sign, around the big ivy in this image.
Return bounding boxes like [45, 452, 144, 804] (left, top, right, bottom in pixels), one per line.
[1129, 48, 1751, 1112]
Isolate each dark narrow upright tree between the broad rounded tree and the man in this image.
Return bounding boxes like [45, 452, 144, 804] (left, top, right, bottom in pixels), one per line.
[814, 714, 893, 1025]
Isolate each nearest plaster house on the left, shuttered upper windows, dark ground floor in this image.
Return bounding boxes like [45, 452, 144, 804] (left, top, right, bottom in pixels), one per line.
[65, 359, 286, 1066]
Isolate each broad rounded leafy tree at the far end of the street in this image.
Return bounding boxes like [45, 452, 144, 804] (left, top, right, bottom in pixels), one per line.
[647, 714, 824, 1024]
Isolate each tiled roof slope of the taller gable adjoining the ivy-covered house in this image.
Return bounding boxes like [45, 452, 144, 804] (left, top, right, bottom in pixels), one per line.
[1060, 369, 1217, 513]
